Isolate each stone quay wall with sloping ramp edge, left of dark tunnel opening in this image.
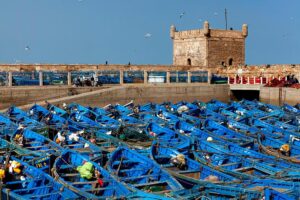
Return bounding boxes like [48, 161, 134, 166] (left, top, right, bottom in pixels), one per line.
[16, 84, 230, 109]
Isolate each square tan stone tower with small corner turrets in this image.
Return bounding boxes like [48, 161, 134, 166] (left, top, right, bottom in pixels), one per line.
[170, 21, 248, 67]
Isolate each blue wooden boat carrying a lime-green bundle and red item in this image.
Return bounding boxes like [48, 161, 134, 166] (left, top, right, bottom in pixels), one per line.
[52, 150, 131, 199]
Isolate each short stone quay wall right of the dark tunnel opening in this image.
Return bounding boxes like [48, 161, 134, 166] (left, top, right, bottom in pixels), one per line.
[260, 87, 300, 105]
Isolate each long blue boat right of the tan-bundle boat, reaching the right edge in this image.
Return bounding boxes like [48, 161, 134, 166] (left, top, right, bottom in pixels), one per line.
[193, 140, 300, 180]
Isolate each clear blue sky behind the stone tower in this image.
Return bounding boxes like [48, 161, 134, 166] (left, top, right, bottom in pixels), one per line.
[0, 0, 300, 64]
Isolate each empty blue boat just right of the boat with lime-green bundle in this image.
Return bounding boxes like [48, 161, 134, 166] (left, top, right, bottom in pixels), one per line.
[107, 147, 183, 195]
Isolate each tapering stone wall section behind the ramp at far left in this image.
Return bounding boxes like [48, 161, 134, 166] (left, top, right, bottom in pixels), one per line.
[0, 86, 107, 109]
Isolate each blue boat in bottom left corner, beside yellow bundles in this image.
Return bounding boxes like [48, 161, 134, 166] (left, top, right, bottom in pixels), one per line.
[0, 157, 80, 200]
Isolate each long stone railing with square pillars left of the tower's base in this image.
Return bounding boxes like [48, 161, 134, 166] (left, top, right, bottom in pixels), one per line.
[0, 65, 211, 87]
